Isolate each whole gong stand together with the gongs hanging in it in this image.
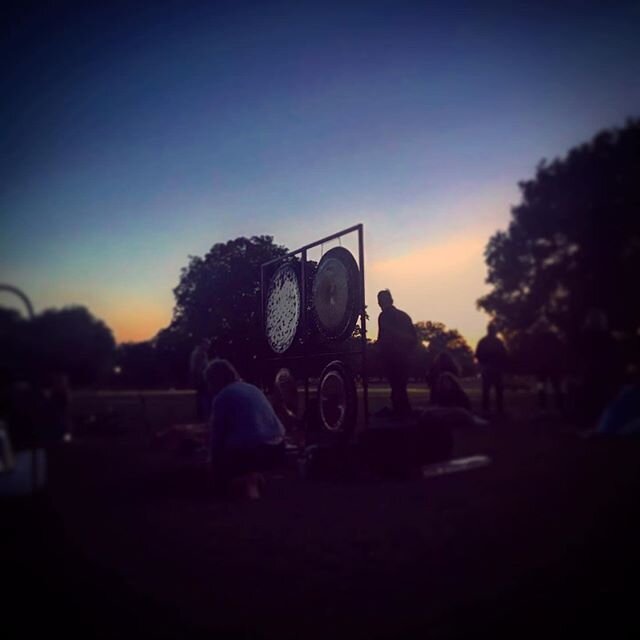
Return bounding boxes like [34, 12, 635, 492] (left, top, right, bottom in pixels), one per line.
[259, 224, 368, 442]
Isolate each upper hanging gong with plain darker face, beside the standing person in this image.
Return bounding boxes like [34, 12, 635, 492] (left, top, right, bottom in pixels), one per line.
[312, 247, 361, 341]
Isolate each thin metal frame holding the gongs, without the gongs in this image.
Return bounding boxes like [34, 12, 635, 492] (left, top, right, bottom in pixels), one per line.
[260, 223, 369, 433]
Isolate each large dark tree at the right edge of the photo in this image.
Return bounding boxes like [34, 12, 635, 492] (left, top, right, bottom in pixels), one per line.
[478, 120, 640, 356]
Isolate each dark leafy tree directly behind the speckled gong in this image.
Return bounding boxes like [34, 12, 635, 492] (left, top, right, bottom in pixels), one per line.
[155, 236, 287, 384]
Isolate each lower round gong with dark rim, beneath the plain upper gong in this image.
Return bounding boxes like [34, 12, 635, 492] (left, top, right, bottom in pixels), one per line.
[318, 360, 358, 436]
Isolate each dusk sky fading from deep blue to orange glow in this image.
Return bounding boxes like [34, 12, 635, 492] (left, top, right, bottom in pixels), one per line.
[0, 0, 640, 344]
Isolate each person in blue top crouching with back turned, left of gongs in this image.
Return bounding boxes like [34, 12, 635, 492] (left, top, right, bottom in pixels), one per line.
[205, 359, 285, 499]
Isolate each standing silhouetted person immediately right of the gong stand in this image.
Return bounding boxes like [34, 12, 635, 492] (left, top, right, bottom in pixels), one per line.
[378, 289, 418, 416]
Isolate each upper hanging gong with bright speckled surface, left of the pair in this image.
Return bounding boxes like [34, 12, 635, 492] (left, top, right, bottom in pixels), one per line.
[264, 264, 301, 353]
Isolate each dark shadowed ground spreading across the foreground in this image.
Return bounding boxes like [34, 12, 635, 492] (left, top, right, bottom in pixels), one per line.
[0, 388, 640, 638]
